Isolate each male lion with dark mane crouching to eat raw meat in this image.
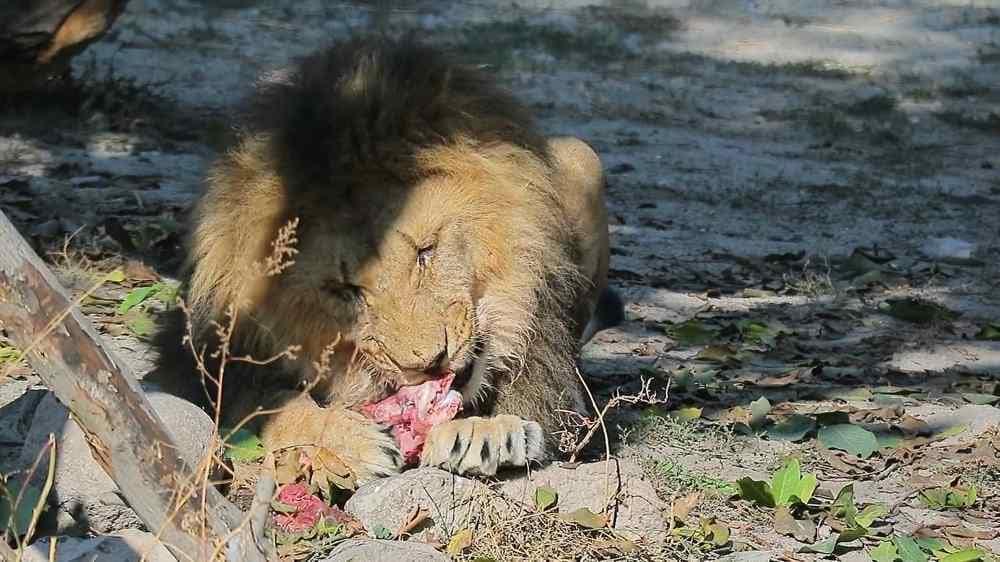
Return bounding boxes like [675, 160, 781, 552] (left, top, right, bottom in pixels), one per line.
[151, 40, 621, 480]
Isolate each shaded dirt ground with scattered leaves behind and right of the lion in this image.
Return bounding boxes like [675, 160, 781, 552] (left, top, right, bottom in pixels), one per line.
[0, 0, 1000, 560]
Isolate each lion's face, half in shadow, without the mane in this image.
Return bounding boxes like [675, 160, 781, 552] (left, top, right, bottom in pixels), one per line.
[279, 173, 477, 392]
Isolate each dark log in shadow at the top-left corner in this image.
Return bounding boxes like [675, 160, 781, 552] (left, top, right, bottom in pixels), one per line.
[0, 0, 128, 93]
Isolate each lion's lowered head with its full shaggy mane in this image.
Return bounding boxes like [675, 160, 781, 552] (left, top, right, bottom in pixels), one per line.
[180, 38, 581, 401]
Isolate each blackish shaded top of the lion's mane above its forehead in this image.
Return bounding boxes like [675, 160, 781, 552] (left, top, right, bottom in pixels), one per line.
[250, 38, 548, 186]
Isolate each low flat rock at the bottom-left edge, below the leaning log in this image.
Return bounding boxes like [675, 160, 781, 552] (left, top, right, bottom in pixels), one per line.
[21, 529, 177, 562]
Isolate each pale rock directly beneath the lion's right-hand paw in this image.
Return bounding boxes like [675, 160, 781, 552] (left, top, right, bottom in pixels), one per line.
[500, 459, 667, 541]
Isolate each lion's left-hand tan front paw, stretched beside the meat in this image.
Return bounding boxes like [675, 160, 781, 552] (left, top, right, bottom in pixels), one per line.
[261, 395, 403, 483]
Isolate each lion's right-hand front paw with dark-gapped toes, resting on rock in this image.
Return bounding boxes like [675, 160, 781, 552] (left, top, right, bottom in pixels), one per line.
[420, 415, 545, 476]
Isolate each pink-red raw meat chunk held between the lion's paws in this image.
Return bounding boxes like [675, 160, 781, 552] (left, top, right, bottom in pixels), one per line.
[361, 373, 462, 464]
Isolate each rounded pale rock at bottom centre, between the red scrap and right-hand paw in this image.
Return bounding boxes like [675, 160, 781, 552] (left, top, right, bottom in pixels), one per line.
[344, 468, 490, 538]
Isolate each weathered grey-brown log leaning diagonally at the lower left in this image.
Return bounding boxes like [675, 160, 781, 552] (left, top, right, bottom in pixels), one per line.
[0, 212, 267, 562]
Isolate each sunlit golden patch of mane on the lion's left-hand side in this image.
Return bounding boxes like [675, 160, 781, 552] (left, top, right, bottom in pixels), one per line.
[188, 137, 288, 319]
